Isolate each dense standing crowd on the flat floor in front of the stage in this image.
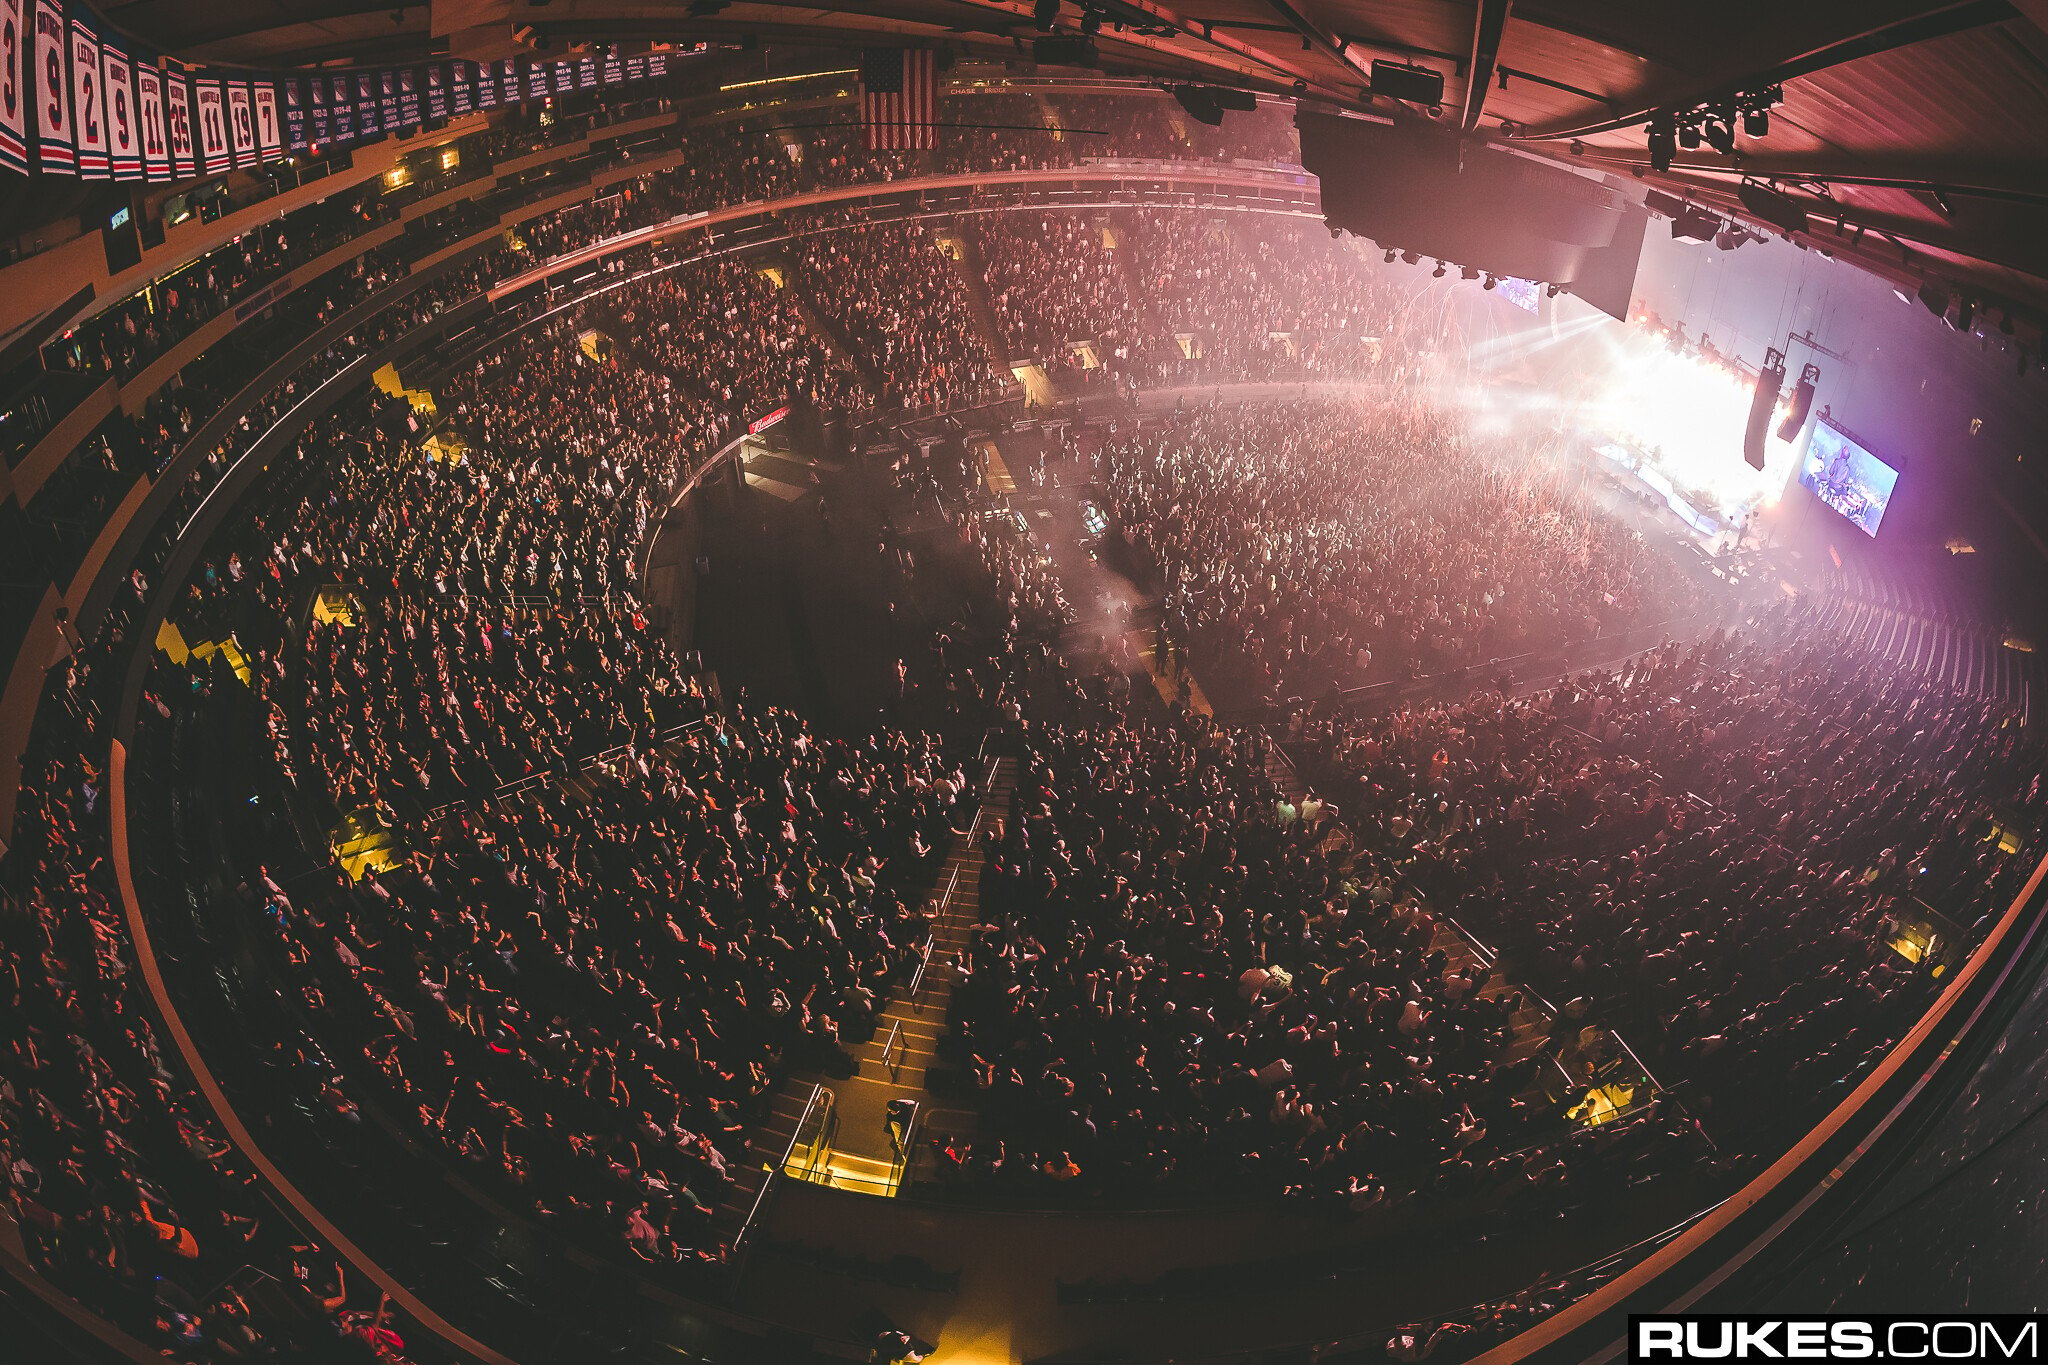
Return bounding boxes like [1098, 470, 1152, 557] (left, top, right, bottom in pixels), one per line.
[1096, 391, 1700, 698]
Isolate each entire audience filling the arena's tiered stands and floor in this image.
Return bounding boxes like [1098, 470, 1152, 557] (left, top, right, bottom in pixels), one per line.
[0, 77, 2044, 1363]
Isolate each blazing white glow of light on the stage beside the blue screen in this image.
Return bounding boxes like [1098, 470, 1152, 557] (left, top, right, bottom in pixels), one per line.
[1585, 332, 1798, 518]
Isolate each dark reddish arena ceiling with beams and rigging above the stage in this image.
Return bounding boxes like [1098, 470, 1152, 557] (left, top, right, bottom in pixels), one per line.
[104, 0, 2048, 321]
